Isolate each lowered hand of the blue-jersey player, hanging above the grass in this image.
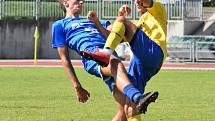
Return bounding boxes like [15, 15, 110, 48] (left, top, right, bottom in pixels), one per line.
[75, 86, 90, 103]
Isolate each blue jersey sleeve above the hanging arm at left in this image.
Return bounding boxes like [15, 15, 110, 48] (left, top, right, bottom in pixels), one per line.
[52, 21, 66, 48]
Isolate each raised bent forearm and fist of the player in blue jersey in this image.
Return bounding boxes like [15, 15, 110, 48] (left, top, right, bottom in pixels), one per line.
[87, 11, 110, 38]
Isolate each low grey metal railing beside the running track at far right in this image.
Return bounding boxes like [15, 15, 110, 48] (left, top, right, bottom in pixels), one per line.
[167, 36, 215, 62]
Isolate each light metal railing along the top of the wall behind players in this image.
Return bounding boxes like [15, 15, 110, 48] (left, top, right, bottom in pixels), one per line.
[0, 0, 202, 20]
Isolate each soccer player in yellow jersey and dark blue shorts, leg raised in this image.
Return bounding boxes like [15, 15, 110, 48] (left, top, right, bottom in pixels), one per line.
[83, 0, 167, 121]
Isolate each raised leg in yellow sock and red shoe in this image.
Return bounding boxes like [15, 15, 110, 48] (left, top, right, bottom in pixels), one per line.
[82, 16, 137, 66]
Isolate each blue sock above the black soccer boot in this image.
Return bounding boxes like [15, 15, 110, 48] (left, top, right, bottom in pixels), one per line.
[123, 84, 142, 103]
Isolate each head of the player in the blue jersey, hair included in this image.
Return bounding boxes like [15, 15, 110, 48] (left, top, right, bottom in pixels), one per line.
[58, 0, 84, 14]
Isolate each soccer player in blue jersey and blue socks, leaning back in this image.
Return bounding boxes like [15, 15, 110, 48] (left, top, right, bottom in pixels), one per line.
[52, 0, 158, 121]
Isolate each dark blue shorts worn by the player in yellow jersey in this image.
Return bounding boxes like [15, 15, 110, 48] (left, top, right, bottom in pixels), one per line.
[128, 29, 163, 94]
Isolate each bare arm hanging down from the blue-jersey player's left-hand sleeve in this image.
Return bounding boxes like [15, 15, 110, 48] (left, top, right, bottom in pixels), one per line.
[57, 46, 90, 103]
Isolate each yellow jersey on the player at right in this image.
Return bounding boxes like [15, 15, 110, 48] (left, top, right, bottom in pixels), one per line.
[136, 2, 167, 59]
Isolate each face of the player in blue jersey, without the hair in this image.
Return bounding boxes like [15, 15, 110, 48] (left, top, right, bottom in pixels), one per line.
[67, 0, 84, 14]
